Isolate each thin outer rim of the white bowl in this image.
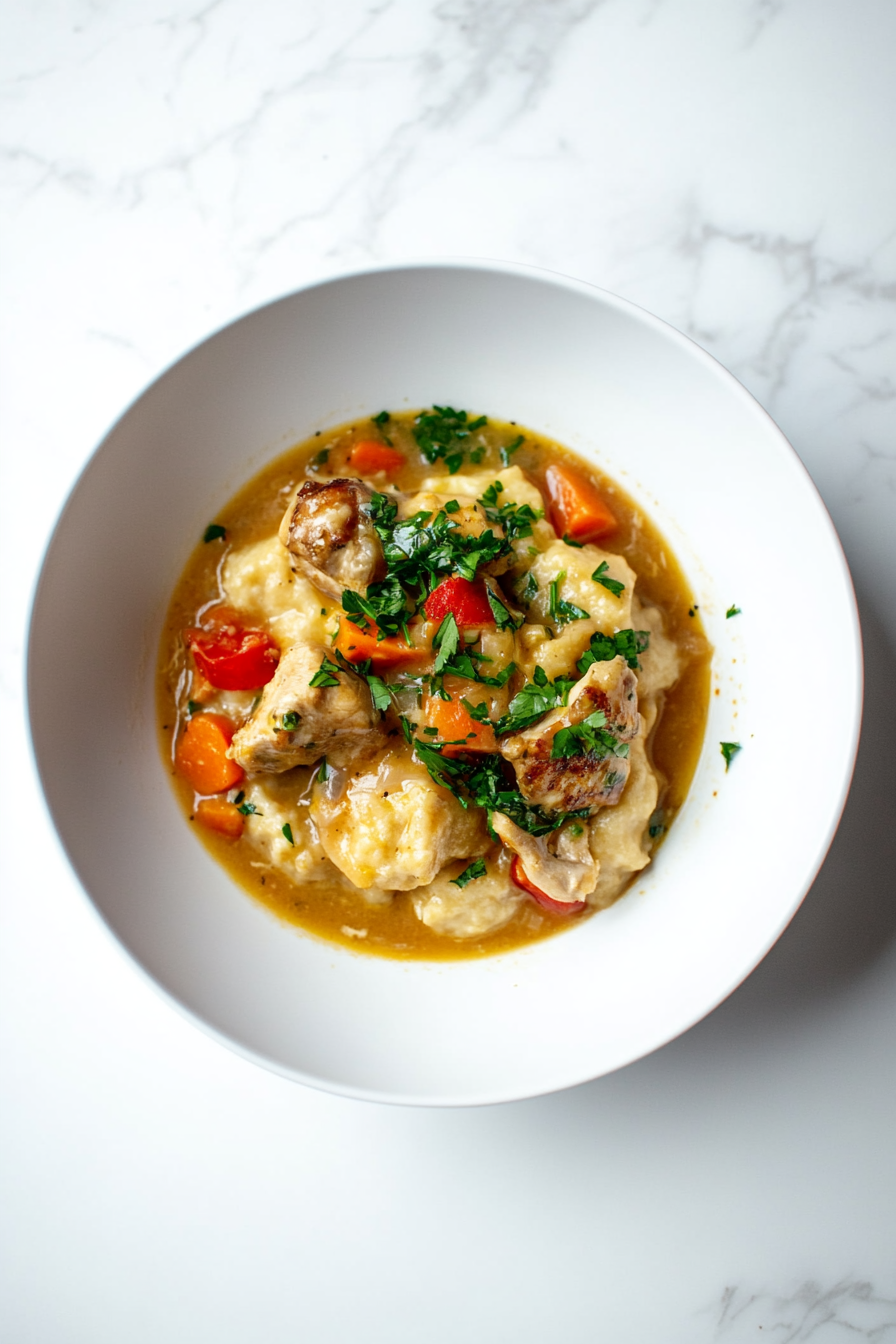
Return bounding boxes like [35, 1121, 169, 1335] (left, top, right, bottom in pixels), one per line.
[23, 255, 864, 1109]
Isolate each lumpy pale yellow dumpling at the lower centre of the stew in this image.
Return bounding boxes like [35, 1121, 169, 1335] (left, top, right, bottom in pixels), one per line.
[310, 750, 490, 891]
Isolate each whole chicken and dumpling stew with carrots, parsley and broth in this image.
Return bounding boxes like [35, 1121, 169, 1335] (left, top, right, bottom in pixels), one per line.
[159, 407, 711, 958]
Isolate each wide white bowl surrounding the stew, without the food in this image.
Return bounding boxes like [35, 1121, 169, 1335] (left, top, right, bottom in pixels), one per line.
[28, 262, 861, 1105]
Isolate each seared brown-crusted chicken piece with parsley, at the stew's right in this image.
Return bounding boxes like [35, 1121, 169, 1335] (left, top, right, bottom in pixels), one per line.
[500, 657, 638, 811]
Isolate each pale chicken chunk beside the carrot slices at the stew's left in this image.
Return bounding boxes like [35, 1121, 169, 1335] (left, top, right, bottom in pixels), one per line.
[228, 642, 384, 774]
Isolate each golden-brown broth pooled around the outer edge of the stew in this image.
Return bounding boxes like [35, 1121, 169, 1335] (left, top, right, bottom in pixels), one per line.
[157, 413, 712, 960]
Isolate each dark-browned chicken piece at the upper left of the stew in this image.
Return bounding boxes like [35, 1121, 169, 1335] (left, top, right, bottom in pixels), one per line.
[279, 478, 386, 601]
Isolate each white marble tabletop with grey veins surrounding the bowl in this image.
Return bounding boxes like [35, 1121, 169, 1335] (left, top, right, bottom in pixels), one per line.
[0, 0, 896, 1344]
